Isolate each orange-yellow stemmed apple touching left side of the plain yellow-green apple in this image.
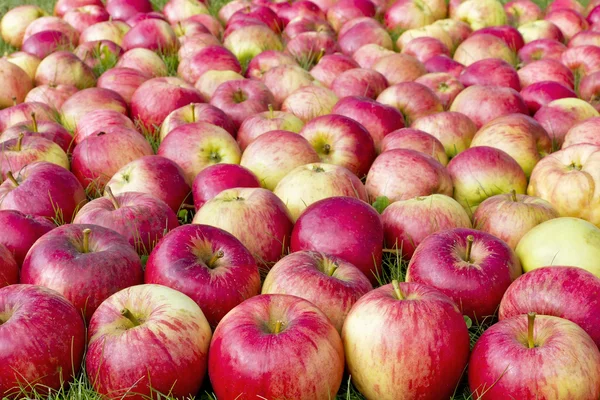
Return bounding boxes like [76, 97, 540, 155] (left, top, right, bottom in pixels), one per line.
[473, 192, 558, 249]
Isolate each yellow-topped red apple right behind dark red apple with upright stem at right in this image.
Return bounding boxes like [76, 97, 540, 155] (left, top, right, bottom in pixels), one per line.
[381, 194, 471, 260]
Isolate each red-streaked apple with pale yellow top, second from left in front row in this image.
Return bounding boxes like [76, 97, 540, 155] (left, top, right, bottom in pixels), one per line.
[85, 284, 211, 400]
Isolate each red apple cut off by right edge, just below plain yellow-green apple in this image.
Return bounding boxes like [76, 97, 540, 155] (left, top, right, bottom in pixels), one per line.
[498, 266, 600, 344]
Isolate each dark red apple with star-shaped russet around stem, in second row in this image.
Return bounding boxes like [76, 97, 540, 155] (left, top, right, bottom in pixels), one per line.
[144, 225, 261, 327]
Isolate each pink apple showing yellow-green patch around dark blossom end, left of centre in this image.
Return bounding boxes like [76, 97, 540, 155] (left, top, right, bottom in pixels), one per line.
[157, 122, 242, 185]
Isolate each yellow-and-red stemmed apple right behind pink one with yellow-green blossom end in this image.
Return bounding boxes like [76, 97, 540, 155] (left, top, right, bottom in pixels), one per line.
[160, 103, 236, 141]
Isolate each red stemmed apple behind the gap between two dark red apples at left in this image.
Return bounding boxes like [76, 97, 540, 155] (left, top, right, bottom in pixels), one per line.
[73, 192, 179, 254]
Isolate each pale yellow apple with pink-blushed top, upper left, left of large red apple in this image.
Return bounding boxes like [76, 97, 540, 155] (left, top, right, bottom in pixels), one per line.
[60, 88, 127, 131]
